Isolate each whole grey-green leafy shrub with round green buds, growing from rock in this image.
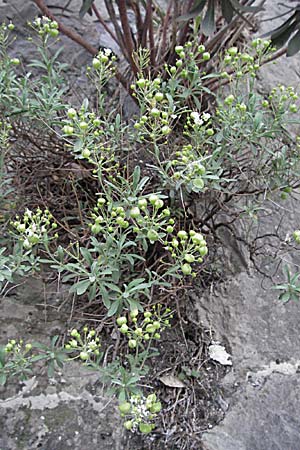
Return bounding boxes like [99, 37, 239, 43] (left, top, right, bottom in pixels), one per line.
[0, 18, 298, 433]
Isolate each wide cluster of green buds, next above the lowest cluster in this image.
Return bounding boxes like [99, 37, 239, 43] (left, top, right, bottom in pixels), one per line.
[117, 304, 173, 349]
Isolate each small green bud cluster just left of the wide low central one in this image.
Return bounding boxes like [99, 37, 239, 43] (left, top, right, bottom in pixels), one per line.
[65, 327, 101, 362]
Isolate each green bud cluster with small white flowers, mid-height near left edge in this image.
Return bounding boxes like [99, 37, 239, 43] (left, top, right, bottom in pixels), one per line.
[11, 208, 58, 250]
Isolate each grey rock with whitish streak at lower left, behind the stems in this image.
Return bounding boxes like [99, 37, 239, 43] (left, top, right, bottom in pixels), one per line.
[0, 279, 125, 450]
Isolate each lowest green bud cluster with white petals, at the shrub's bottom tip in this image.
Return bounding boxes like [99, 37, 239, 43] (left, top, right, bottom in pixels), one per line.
[119, 394, 161, 434]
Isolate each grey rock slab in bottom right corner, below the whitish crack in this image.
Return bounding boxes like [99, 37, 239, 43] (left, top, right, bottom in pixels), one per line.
[204, 374, 300, 450]
